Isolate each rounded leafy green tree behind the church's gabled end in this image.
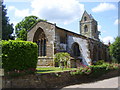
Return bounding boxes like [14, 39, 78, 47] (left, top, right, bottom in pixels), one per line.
[15, 15, 46, 41]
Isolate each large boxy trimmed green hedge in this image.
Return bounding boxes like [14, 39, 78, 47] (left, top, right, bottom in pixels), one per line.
[2, 40, 38, 72]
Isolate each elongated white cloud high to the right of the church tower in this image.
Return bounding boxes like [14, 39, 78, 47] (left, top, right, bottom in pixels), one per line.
[92, 3, 116, 12]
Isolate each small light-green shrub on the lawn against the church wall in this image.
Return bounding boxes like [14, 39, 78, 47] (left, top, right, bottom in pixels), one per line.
[54, 52, 70, 67]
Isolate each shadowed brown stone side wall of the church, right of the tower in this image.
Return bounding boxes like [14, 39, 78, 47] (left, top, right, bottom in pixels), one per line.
[88, 39, 111, 62]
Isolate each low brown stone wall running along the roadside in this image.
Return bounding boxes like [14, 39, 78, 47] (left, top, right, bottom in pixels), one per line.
[2, 70, 118, 88]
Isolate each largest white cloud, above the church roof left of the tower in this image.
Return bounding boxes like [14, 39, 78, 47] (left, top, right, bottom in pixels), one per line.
[31, 0, 84, 24]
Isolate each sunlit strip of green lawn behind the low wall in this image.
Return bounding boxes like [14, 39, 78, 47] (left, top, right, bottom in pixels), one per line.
[36, 67, 76, 73]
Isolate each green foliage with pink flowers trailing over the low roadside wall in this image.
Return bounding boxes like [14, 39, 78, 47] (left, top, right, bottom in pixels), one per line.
[70, 63, 120, 78]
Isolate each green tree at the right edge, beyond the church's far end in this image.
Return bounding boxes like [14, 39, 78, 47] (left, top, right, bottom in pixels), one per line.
[110, 37, 120, 63]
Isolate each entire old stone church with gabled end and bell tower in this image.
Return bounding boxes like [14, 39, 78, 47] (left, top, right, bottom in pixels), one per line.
[27, 11, 110, 67]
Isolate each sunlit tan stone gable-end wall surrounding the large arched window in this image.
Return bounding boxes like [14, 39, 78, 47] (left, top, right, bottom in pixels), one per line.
[27, 21, 55, 66]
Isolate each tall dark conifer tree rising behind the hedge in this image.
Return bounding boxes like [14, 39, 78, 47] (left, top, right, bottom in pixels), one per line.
[2, 3, 14, 40]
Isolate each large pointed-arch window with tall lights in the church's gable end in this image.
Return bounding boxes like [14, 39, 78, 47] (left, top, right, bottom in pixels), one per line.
[33, 28, 46, 56]
